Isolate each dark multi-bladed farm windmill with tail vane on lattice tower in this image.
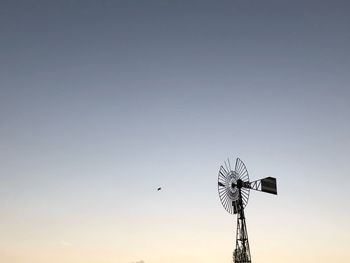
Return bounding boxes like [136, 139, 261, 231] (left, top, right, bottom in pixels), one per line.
[218, 158, 277, 263]
